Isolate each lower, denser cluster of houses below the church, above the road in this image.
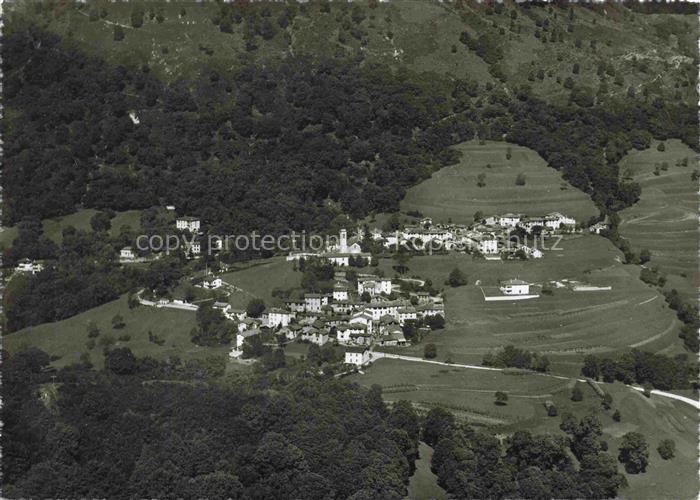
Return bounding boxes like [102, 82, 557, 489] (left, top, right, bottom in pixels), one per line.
[228, 271, 445, 364]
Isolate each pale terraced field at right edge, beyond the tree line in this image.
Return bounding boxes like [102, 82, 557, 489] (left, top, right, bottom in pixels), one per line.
[619, 140, 700, 300]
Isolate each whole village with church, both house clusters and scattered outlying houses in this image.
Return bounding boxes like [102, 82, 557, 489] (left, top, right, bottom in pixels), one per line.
[17, 206, 607, 367]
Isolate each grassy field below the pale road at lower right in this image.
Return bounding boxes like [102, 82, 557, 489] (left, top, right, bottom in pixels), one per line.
[352, 359, 698, 500]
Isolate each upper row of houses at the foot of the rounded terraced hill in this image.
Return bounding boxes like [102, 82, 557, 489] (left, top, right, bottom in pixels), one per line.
[371, 212, 576, 259]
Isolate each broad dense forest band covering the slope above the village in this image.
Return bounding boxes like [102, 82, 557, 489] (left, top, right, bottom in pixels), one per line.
[2, 28, 697, 234]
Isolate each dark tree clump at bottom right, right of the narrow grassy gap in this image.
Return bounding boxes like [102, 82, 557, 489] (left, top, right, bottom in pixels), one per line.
[423, 408, 627, 498]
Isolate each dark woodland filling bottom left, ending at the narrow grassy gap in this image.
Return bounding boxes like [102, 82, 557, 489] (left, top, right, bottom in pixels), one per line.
[1, 348, 419, 500]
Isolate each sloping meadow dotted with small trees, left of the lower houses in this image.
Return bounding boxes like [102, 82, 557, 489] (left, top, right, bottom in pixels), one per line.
[3, 297, 228, 368]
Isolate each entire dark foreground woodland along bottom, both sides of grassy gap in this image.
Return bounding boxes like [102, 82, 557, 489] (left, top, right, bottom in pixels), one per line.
[2, 348, 626, 500]
